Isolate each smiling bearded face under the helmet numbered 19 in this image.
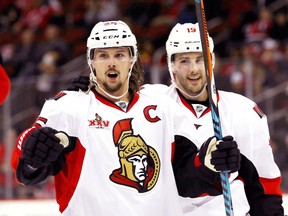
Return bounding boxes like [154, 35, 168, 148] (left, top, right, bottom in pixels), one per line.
[173, 52, 206, 99]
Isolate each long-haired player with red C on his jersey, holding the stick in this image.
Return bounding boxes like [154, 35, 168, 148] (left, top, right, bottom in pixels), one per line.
[11, 21, 240, 216]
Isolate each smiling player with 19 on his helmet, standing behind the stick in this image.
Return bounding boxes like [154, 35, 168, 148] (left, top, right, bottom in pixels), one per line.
[70, 23, 284, 216]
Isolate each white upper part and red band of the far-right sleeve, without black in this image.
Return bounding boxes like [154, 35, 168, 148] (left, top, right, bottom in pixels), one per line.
[235, 100, 282, 192]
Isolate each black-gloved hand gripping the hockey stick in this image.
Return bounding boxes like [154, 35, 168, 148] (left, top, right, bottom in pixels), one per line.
[199, 136, 241, 172]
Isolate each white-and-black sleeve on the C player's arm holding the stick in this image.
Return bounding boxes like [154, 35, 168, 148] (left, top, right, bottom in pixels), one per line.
[170, 99, 221, 198]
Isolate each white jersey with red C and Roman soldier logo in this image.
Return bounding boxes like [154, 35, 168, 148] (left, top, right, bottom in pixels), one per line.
[14, 88, 200, 216]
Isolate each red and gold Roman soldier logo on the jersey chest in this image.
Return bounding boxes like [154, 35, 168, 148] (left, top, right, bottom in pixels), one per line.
[110, 118, 160, 193]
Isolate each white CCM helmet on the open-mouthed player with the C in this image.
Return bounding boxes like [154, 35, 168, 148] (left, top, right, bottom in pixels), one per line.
[87, 20, 138, 65]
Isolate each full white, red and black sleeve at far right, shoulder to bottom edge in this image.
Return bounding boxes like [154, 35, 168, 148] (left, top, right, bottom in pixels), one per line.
[228, 93, 283, 215]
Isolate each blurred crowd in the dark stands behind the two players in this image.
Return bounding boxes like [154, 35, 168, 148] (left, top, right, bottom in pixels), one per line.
[0, 0, 288, 198]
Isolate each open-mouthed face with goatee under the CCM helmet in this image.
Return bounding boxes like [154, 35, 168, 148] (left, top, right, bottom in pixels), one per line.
[92, 47, 132, 96]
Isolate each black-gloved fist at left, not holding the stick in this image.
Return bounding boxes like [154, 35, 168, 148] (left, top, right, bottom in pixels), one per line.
[22, 127, 64, 169]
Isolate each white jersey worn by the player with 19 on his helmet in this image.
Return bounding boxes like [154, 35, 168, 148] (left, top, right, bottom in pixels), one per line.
[144, 85, 282, 216]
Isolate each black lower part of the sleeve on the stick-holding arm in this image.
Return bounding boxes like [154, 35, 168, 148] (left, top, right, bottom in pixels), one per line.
[172, 136, 222, 198]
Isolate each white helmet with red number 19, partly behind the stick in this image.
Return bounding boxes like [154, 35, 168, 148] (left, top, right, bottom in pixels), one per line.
[166, 23, 214, 82]
